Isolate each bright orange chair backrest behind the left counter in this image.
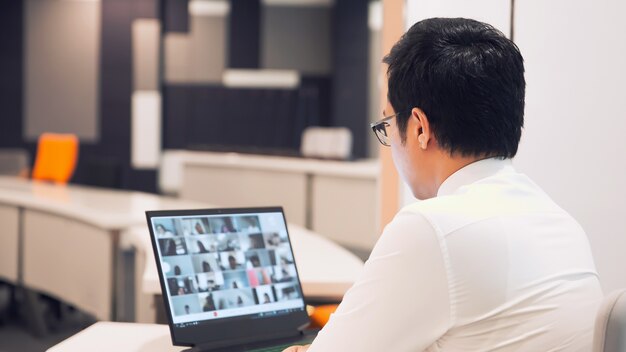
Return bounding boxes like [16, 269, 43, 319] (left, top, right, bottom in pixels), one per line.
[32, 133, 78, 183]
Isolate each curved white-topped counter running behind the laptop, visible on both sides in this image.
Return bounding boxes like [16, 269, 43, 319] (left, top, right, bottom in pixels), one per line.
[0, 177, 363, 322]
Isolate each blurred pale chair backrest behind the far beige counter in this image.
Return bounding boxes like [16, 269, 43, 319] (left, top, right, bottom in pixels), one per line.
[300, 127, 352, 160]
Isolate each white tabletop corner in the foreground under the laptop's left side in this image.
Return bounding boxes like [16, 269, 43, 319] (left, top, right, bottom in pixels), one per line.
[48, 322, 184, 352]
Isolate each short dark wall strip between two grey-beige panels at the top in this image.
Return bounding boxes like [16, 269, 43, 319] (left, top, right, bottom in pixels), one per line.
[228, 0, 261, 68]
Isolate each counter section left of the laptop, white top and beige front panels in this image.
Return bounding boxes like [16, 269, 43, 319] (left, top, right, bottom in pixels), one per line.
[0, 177, 204, 320]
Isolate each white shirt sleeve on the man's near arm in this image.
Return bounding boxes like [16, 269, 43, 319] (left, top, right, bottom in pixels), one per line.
[309, 211, 451, 352]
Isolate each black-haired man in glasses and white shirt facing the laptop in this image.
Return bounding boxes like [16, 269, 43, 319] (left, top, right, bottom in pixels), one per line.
[288, 18, 602, 352]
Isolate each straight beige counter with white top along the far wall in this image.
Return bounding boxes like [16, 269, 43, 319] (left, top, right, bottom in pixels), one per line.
[160, 151, 380, 250]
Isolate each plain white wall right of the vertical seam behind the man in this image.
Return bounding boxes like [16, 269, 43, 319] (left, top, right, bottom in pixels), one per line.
[515, 0, 626, 292]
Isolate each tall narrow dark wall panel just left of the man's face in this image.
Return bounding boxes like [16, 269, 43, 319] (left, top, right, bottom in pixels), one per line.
[332, 0, 369, 157]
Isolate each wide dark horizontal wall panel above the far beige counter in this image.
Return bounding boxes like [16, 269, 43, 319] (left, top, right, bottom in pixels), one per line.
[163, 81, 330, 154]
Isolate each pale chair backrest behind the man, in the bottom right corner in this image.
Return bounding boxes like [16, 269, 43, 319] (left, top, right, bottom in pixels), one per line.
[593, 289, 626, 352]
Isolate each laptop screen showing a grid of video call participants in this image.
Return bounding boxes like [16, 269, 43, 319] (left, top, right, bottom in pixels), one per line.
[150, 208, 305, 328]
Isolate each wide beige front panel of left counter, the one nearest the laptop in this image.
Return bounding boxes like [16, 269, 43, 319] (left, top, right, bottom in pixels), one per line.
[22, 210, 117, 320]
